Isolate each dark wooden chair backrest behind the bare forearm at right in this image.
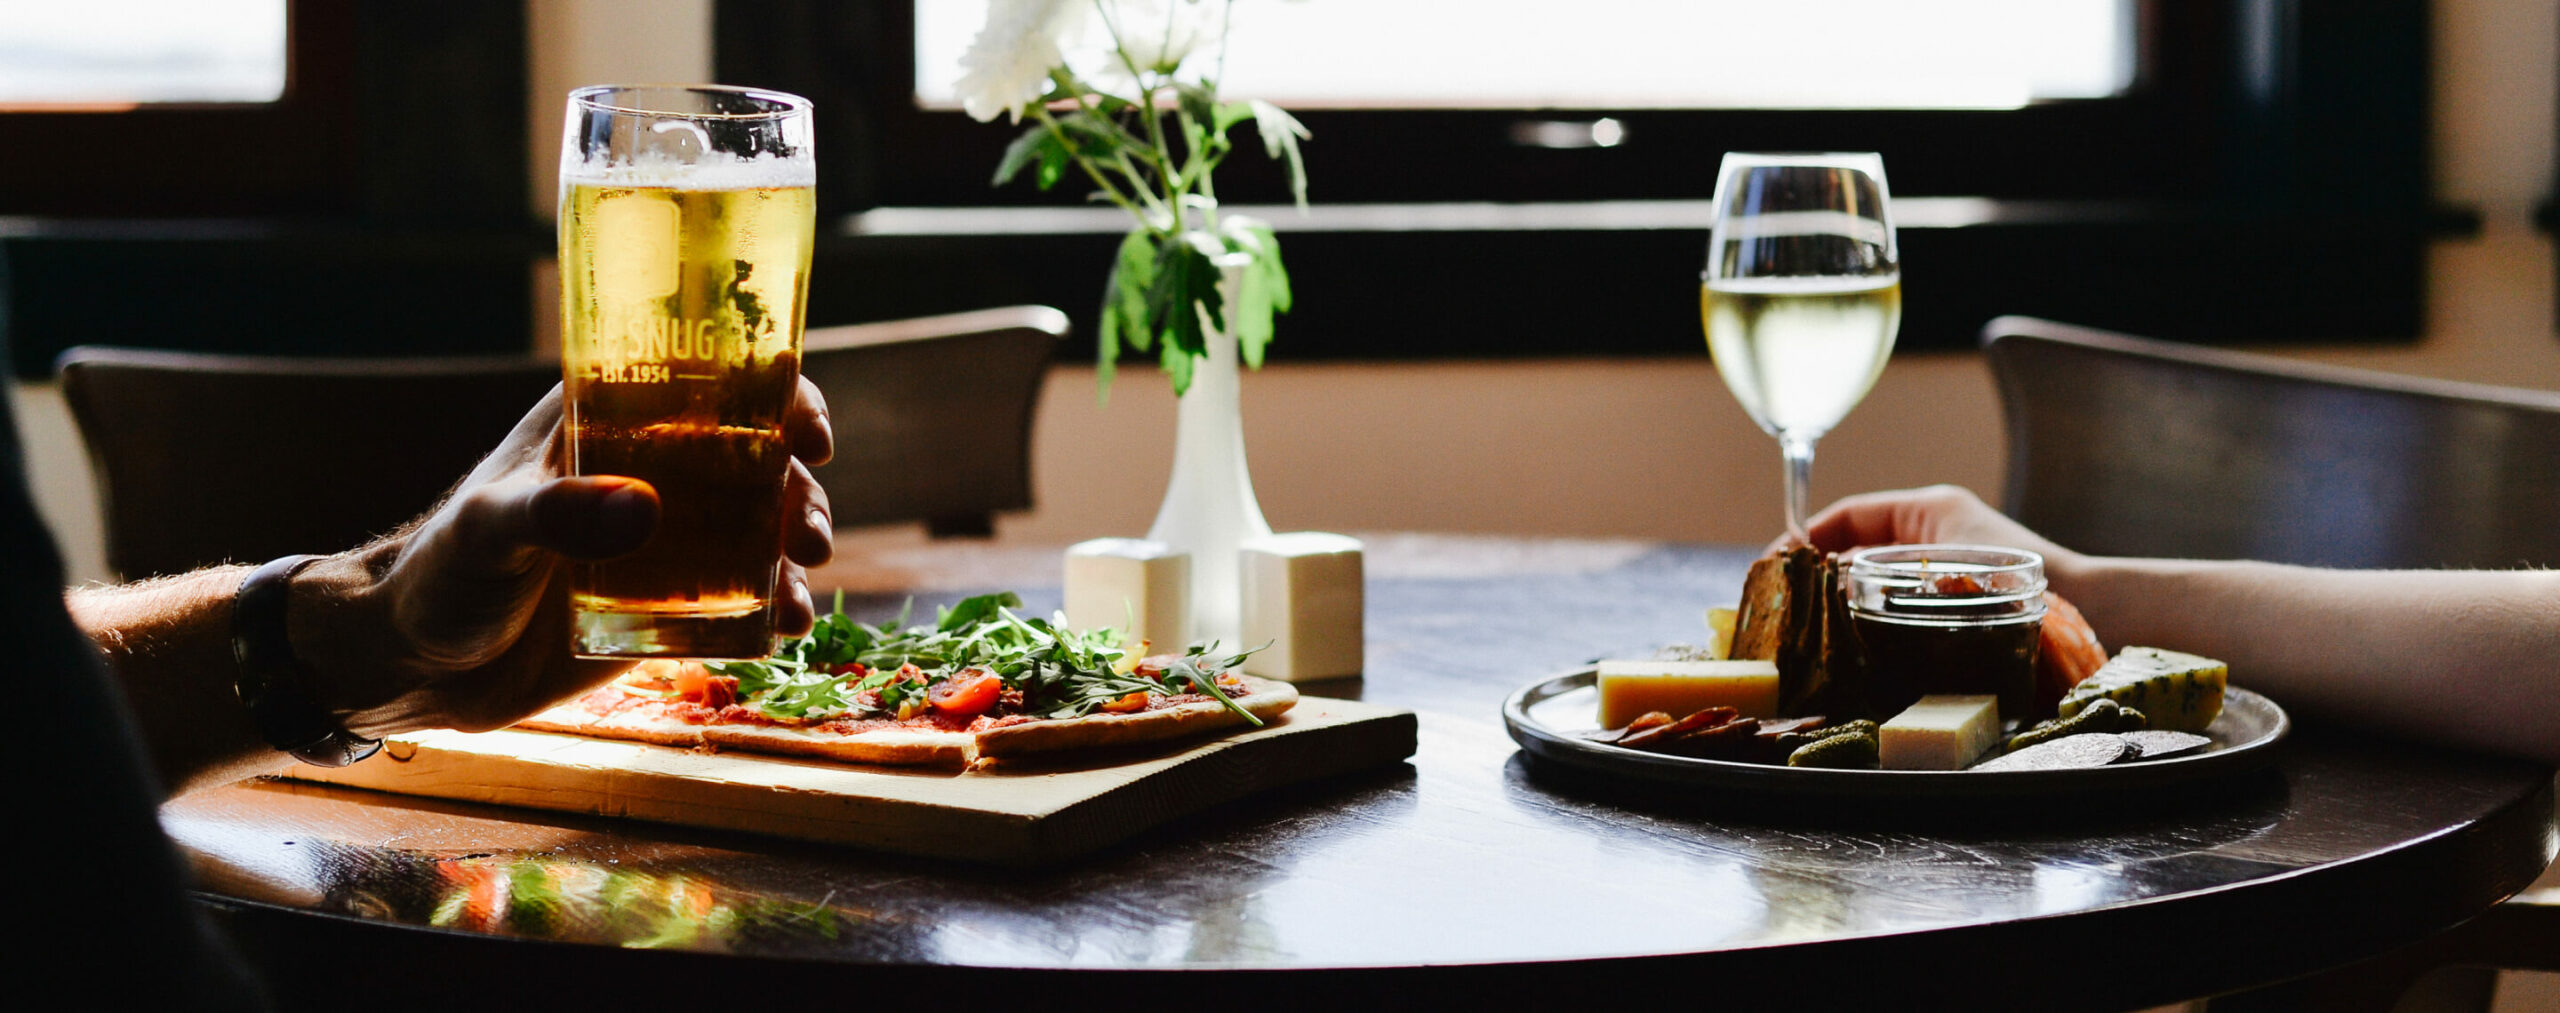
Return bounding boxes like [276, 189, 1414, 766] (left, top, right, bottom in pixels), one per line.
[1984, 317, 2560, 568]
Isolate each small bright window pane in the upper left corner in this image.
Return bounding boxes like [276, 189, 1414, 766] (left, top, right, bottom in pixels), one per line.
[0, 0, 287, 107]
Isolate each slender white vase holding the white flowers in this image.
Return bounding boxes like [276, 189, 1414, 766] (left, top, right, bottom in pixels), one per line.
[1147, 271, 1272, 650]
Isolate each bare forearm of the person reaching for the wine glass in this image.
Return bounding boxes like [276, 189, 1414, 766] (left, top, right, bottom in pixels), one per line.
[2053, 558, 2560, 762]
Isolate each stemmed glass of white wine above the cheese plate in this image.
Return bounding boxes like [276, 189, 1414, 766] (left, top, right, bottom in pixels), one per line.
[1697, 151, 1902, 542]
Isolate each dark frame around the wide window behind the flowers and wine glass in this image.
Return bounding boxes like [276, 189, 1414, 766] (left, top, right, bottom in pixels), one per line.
[714, 0, 2476, 358]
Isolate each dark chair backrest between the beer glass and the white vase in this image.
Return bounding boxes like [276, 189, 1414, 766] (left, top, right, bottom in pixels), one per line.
[801, 307, 1068, 537]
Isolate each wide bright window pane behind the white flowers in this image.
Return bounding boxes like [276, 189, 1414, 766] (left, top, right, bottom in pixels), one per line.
[914, 0, 2135, 110]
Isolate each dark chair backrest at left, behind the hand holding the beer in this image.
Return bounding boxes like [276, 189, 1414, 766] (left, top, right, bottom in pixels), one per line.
[56, 348, 561, 578]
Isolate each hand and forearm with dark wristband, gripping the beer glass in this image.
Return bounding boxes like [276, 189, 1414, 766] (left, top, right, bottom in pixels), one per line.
[69, 379, 835, 790]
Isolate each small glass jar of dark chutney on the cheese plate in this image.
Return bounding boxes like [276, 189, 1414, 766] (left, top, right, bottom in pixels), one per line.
[1841, 545, 2045, 721]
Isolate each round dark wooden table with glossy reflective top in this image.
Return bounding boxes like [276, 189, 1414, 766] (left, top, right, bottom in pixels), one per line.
[161, 535, 2560, 1010]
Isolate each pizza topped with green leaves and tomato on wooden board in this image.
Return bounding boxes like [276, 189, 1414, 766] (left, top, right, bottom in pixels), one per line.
[517, 593, 1298, 767]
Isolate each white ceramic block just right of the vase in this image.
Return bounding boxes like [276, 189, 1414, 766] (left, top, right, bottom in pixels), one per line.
[1229, 532, 1364, 680]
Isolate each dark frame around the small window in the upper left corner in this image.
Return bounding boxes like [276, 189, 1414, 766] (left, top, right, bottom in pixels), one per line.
[0, 0, 535, 379]
